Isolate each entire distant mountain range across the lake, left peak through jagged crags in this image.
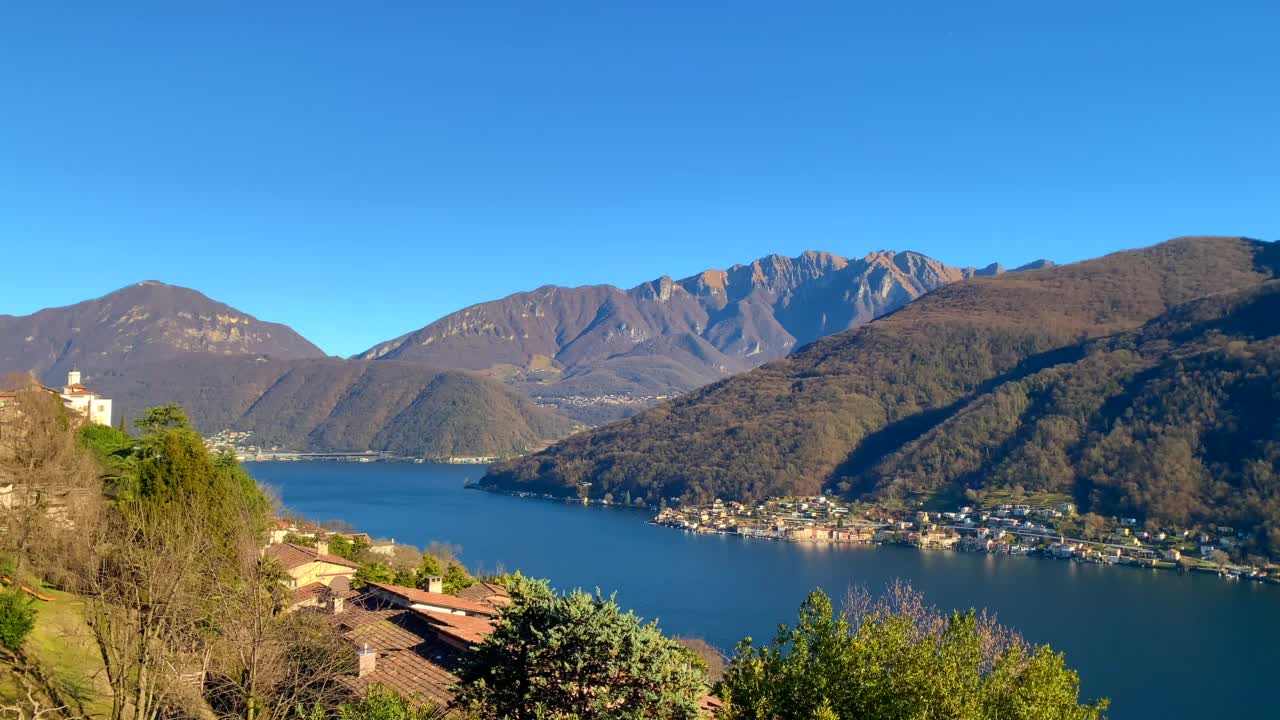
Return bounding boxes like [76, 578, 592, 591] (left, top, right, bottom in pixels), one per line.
[0, 245, 1003, 448]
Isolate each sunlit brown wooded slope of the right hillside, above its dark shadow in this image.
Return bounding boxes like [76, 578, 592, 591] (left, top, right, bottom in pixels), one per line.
[485, 238, 1276, 502]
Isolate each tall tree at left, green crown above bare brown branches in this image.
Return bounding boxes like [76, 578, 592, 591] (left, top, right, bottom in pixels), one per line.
[74, 405, 270, 720]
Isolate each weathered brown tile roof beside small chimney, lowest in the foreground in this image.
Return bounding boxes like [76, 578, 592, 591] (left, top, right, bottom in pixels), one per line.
[329, 594, 468, 707]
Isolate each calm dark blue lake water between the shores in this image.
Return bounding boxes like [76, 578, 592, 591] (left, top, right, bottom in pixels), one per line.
[246, 462, 1280, 719]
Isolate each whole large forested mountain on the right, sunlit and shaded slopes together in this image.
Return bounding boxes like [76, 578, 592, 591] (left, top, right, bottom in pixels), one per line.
[484, 237, 1280, 552]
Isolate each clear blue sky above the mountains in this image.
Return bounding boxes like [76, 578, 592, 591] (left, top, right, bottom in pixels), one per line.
[0, 0, 1280, 355]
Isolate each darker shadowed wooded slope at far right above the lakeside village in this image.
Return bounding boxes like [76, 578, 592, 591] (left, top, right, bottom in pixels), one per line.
[837, 281, 1280, 553]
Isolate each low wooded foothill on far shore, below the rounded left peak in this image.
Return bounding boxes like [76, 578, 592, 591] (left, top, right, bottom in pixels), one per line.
[96, 355, 573, 456]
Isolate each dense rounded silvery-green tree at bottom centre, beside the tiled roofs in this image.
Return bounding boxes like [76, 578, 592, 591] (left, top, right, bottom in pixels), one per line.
[454, 578, 705, 720]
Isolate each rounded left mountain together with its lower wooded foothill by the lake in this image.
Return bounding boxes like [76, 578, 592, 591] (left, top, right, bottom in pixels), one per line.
[0, 281, 575, 456]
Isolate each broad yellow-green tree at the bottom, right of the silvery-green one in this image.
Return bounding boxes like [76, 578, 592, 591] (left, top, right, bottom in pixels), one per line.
[722, 585, 1107, 720]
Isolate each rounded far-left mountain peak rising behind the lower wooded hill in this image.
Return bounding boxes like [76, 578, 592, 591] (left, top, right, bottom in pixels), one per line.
[0, 281, 324, 384]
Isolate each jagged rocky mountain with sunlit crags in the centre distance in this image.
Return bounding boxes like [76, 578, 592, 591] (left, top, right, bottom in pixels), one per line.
[358, 251, 998, 421]
